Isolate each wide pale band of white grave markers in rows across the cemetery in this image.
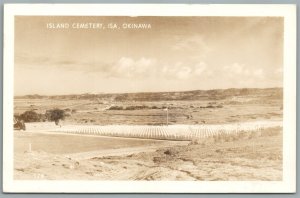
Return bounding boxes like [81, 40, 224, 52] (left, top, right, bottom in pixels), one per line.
[53, 121, 282, 140]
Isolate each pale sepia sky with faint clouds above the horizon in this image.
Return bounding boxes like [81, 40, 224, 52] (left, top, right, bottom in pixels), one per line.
[14, 16, 283, 95]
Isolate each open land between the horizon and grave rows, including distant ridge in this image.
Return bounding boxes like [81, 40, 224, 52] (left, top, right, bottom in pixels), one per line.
[14, 88, 283, 125]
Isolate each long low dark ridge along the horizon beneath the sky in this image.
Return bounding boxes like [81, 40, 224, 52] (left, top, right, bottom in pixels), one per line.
[15, 87, 283, 101]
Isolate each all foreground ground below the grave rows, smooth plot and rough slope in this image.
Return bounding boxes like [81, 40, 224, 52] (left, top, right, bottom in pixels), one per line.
[14, 128, 282, 181]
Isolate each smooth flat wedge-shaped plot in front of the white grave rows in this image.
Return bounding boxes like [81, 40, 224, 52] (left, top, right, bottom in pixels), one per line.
[14, 131, 180, 154]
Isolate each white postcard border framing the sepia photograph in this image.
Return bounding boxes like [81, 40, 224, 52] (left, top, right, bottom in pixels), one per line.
[3, 4, 296, 193]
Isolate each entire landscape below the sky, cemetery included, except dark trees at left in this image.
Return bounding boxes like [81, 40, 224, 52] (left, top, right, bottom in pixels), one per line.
[14, 88, 283, 181]
